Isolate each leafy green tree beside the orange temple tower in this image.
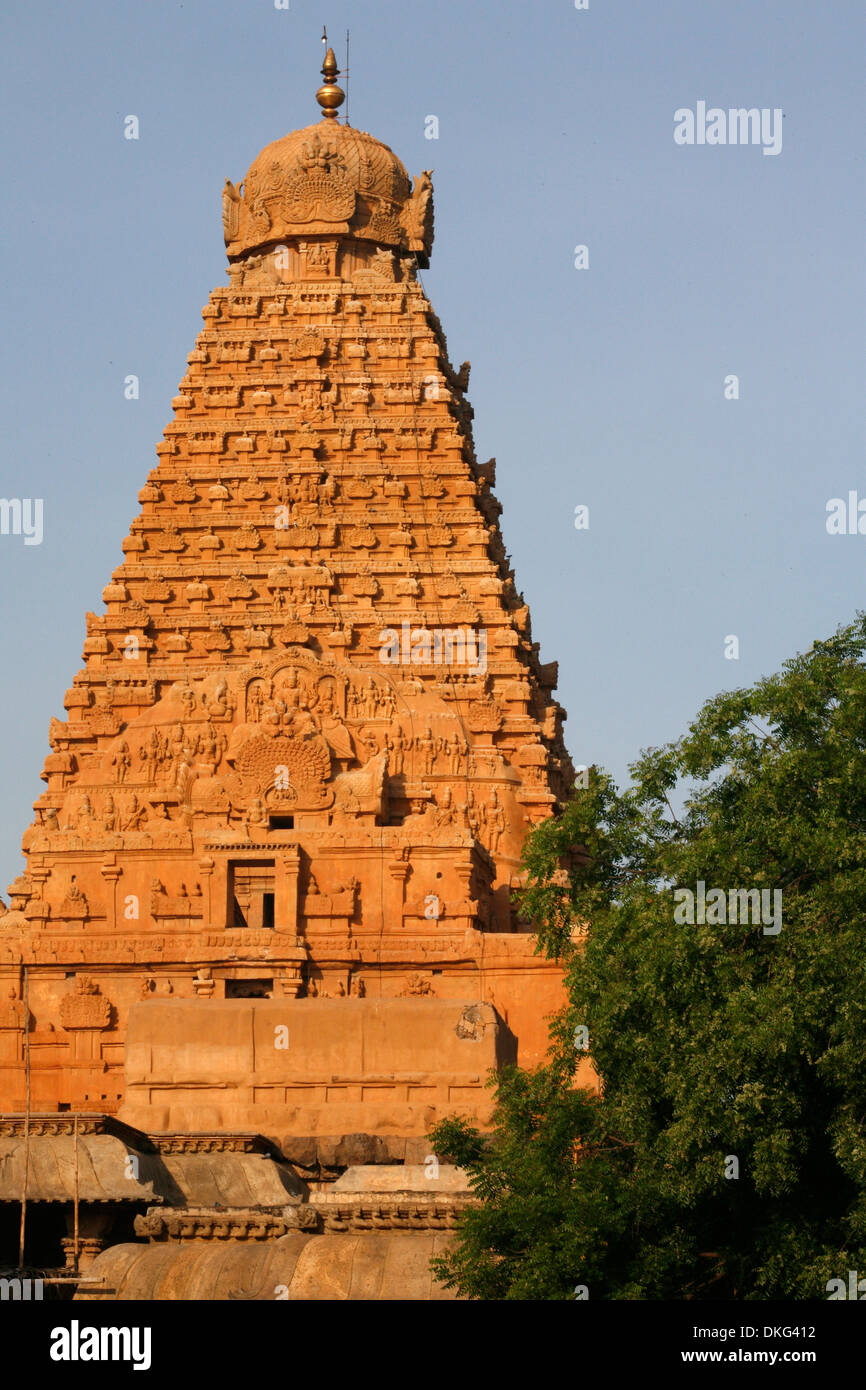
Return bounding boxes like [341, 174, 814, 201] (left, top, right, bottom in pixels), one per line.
[431, 614, 866, 1300]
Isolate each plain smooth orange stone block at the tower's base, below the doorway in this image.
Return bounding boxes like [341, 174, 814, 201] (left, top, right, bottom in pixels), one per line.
[121, 998, 516, 1143]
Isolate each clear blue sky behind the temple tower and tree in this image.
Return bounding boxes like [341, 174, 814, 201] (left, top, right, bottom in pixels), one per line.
[0, 0, 866, 888]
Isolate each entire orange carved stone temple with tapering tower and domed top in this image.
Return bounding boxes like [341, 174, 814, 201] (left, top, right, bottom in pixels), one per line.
[0, 51, 573, 1300]
